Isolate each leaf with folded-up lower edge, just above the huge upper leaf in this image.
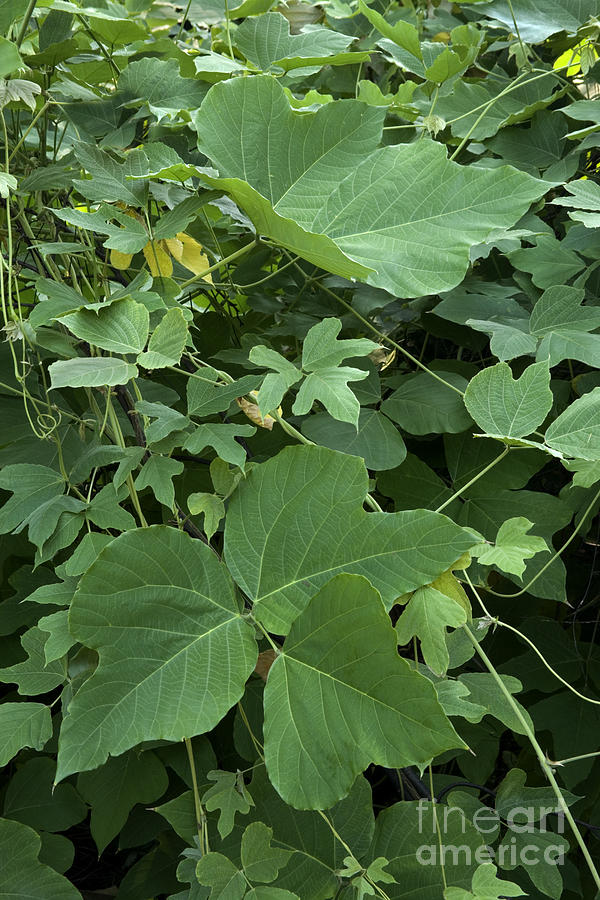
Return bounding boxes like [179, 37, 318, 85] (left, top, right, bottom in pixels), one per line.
[235, 12, 370, 72]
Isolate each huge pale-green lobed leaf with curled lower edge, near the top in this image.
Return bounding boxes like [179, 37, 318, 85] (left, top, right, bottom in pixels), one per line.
[194, 76, 546, 297]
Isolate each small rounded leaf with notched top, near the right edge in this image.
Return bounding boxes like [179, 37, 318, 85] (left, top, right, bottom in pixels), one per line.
[465, 362, 553, 439]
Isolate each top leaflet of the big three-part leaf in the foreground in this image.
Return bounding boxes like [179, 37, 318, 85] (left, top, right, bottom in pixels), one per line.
[225, 447, 478, 634]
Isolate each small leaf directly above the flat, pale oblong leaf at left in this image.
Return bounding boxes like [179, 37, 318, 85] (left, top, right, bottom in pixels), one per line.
[60, 298, 149, 353]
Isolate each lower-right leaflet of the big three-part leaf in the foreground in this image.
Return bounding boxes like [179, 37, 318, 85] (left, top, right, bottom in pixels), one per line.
[264, 575, 460, 809]
